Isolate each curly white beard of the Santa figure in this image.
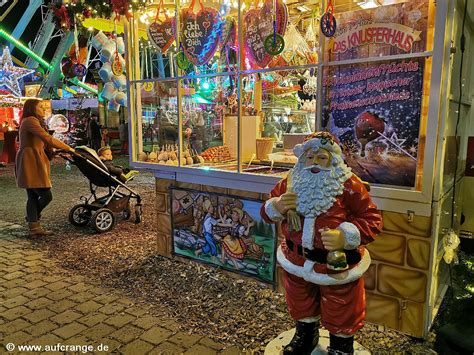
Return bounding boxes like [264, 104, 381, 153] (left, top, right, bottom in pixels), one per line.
[292, 162, 352, 217]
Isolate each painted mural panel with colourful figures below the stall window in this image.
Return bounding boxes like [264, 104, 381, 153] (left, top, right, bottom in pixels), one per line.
[170, 187, 276, 283]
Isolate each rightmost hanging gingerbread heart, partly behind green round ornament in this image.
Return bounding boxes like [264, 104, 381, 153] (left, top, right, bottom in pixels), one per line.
[244, 0, 288, 68]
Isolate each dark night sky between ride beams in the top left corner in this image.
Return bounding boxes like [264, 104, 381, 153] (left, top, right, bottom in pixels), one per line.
[0, 0, 59, 62]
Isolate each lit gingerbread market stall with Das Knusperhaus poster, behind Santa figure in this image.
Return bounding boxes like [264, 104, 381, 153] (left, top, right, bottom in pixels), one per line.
[125, 0, 468, 337]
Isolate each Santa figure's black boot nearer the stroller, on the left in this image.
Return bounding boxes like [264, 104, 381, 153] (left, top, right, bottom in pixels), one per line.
[283, 321, 319, 355]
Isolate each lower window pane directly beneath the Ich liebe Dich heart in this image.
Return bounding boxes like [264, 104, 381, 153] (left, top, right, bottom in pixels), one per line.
[179, 75, 239, 171]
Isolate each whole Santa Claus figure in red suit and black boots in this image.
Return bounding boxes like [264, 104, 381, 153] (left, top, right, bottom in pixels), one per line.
[261, 132, 382, 354]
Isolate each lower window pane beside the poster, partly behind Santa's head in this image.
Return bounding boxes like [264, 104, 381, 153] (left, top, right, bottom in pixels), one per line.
[241, 68, 317, 176]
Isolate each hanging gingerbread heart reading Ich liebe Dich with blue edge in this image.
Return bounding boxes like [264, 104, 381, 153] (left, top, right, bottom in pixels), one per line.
[180, 0, 221, 65]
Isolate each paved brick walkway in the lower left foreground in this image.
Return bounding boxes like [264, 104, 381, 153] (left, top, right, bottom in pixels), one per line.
[0, 221, 238, 355]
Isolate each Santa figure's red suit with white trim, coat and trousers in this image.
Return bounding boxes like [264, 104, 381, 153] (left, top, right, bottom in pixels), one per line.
[261, 175, 382, 334]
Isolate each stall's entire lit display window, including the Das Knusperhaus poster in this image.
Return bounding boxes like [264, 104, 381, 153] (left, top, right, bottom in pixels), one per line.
[127, 0, 436, 191]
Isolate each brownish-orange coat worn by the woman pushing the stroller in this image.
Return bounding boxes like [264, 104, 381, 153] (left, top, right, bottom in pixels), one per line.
[15, 117, 70, 189]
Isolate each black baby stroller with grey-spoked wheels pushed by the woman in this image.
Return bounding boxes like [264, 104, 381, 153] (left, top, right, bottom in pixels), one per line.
[61, 146, 142, 233]
